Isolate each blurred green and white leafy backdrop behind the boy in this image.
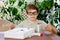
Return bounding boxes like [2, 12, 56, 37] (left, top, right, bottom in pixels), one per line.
[0, 0, 60, 31]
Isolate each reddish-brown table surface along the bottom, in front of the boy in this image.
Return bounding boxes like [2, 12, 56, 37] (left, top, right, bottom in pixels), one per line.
[5, 34, 60, 40]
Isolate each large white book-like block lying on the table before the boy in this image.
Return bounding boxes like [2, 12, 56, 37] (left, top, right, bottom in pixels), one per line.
[4, 28, 34, 39]
